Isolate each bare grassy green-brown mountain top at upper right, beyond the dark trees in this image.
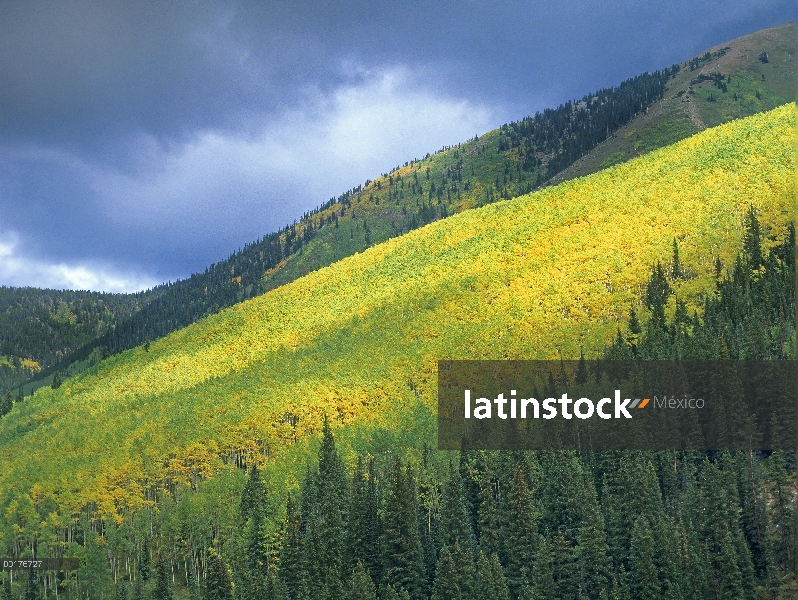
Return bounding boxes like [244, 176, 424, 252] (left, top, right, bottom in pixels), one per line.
[549, 23, 796, 184]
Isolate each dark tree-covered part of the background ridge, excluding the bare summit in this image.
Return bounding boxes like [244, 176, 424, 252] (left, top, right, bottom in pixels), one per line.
[0, 65, 679, 390]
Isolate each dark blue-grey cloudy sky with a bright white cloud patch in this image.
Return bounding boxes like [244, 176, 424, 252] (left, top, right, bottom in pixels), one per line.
[0, 0, 795, 292]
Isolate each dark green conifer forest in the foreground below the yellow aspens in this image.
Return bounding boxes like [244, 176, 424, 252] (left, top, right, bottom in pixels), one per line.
[0, 209, 798, 600]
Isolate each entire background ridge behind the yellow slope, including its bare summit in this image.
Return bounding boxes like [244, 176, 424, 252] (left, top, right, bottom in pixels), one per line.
[0, 24, 795, 393]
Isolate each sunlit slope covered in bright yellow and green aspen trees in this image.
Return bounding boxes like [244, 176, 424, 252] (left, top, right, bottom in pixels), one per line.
[0, 104, 795, 512]
